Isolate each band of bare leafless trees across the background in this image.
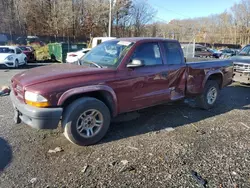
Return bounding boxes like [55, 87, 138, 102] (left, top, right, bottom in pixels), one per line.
[0, 0, 250, 45]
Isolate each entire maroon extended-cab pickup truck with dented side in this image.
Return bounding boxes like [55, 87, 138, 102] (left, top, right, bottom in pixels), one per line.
[11, 38, 233, 145]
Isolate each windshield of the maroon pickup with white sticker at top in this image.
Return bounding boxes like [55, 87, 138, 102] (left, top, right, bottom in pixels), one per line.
[80, 40, 133, 67]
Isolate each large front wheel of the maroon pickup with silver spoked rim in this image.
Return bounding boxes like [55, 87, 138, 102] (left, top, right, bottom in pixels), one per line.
[62, 97, 110, 146]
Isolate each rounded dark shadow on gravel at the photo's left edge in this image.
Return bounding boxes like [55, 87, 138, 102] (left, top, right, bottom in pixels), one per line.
[0, 137, 12, 175]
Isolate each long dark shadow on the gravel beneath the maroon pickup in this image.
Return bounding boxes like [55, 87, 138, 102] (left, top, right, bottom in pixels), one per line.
[102, 84, 250, 143]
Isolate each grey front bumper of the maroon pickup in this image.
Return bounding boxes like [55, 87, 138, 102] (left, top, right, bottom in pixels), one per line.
[10, 92, 63, 129]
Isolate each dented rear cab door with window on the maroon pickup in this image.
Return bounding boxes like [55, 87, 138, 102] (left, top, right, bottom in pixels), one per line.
[162, 41, 187, 101]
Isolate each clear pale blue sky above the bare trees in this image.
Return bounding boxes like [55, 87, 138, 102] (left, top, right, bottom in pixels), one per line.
[147, 0, 240, 22]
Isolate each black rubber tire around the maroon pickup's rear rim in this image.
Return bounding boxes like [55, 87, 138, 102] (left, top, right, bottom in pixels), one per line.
[196, 80, 219, 110]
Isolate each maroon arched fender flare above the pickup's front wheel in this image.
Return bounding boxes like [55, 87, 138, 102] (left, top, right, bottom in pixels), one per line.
[57, 85, 118, 116]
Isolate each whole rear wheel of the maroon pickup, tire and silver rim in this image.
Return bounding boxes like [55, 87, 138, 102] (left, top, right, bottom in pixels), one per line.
[197, 80, 219, 110]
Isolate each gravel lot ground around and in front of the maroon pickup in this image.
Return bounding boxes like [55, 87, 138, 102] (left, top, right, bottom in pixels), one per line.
[0, 67, 250, 188]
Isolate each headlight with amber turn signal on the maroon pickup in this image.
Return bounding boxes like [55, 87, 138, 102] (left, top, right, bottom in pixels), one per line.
[24, 91, 49, 108]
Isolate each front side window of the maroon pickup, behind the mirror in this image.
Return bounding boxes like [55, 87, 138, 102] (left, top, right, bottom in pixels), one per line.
[132, 42, 162, 66]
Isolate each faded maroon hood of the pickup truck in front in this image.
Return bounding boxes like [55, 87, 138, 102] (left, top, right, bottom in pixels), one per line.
[12, 64, 114, 87]
